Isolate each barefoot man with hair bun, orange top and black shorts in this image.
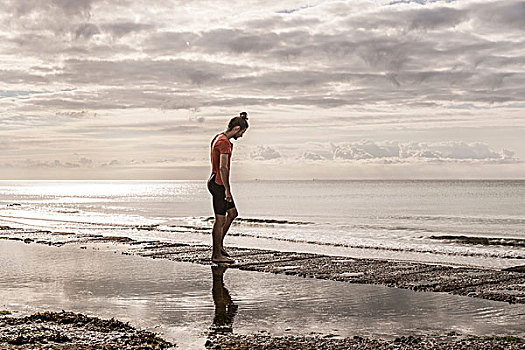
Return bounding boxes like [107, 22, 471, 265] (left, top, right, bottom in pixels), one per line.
[208, 112, 248, 263]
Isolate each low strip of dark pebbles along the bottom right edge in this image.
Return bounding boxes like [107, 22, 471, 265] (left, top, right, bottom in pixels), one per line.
[206, 334, 525, 350]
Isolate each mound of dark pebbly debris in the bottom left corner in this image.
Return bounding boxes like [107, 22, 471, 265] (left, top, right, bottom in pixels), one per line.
[0, 311, 175, 350]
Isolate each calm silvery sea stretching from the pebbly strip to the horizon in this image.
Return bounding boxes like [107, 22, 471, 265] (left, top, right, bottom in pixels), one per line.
[0, 181, 525, 267]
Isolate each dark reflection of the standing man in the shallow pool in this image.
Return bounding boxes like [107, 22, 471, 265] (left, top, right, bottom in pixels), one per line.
[211, 265, 237, 333]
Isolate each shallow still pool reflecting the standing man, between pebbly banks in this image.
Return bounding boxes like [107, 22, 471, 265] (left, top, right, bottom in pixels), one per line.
[0, 241, 525, 349]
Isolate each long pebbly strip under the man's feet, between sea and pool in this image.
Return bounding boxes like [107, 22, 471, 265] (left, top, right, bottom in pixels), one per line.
[0, 226, 525, 304]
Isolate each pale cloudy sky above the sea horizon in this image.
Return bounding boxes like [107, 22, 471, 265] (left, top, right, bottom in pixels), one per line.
[0, 0, 525, 180]
